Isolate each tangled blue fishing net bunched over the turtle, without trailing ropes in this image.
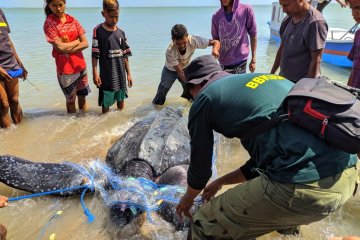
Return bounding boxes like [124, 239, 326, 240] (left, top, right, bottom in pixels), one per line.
[67, 160, 215, 220]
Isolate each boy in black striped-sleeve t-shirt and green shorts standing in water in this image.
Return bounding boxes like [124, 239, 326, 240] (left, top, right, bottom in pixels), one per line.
[92, 0, 133, 113]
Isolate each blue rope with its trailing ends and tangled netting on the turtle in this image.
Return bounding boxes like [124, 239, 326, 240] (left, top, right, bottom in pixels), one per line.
[4, 159, 211, 223]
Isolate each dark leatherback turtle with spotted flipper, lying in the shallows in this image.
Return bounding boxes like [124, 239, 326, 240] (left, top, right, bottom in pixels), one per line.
[0, 107, 194, 230]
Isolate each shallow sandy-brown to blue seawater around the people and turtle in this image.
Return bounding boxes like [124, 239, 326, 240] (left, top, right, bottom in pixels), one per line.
[0, 3, 360, 240]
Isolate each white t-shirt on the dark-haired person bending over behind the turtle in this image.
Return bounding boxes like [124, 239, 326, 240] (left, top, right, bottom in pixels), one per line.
[165, 35, 209, 71]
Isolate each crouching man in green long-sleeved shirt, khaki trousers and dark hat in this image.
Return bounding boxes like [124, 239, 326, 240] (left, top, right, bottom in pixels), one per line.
[176, 55, 358, 239]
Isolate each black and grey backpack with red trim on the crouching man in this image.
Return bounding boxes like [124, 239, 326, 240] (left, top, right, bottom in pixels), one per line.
[239, 77, 360, 154]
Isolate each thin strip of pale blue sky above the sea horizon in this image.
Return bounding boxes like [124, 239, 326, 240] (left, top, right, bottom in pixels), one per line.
[0, 0, 272, 8]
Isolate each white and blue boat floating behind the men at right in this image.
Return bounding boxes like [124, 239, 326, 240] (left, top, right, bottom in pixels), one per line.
[268, 1, 359, 68]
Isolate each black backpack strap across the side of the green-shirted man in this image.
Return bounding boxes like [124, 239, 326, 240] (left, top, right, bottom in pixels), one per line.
[239, 114, 289, 140]
